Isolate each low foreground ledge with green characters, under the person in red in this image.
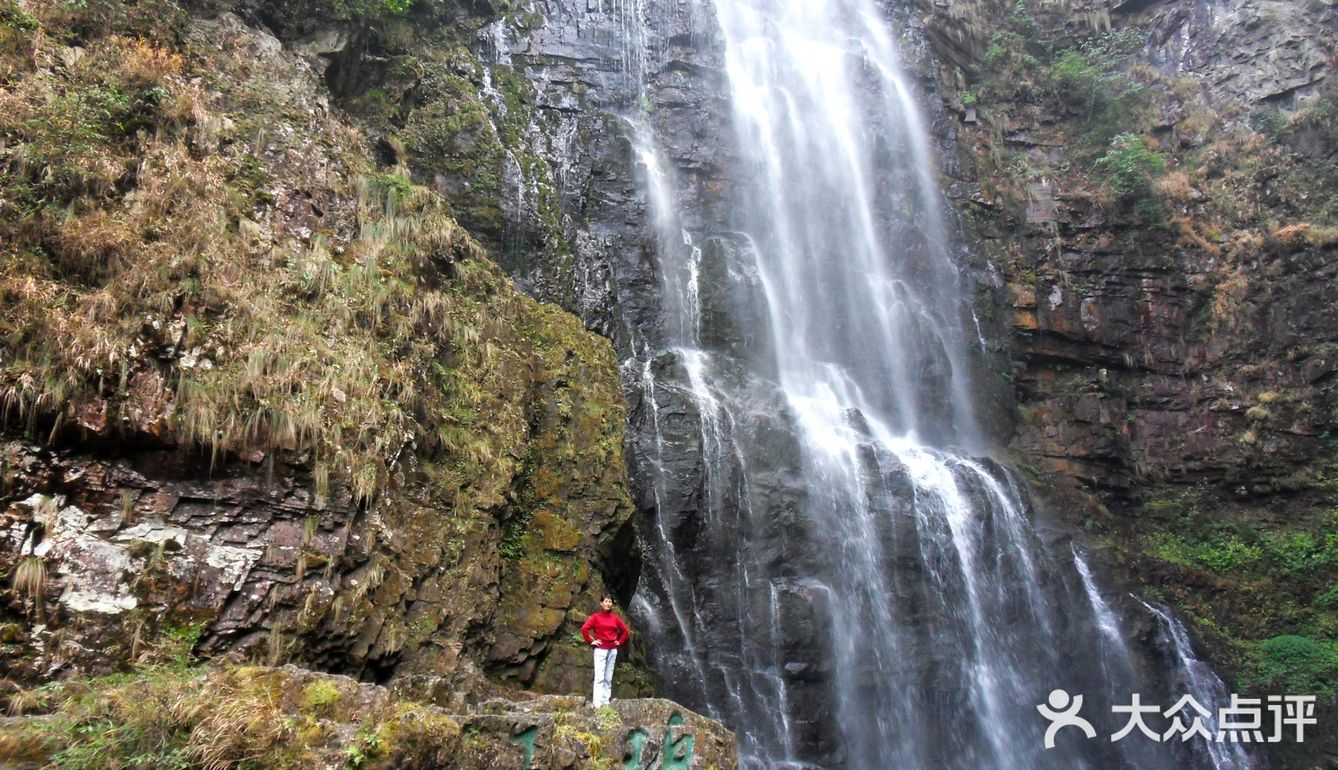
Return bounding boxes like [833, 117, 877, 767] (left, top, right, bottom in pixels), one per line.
[0, 666, 737, 770]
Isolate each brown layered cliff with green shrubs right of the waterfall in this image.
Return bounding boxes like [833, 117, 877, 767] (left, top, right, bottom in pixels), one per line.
[915, 1, 1338, 767]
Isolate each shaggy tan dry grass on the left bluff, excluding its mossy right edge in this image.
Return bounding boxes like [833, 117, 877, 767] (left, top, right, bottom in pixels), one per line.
[0, 4, 521, 499]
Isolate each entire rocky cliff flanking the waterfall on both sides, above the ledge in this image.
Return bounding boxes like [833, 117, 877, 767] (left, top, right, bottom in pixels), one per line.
[0, 0, 1338, 763]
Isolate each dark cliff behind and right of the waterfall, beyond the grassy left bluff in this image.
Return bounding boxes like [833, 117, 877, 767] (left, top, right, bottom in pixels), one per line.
[252, 0, 1338, 757]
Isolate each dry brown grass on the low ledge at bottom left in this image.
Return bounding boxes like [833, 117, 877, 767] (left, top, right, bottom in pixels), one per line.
[0, 667, 460, 770]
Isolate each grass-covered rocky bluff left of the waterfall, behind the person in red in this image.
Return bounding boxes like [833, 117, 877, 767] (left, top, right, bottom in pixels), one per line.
[0, 3, 649, 703]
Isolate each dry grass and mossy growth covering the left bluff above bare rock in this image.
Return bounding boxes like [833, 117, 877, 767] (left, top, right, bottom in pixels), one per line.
[0, 0, 622, 541]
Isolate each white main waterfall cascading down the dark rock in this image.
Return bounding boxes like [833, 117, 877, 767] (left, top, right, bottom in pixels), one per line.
[628, 0, 1246, 770]
